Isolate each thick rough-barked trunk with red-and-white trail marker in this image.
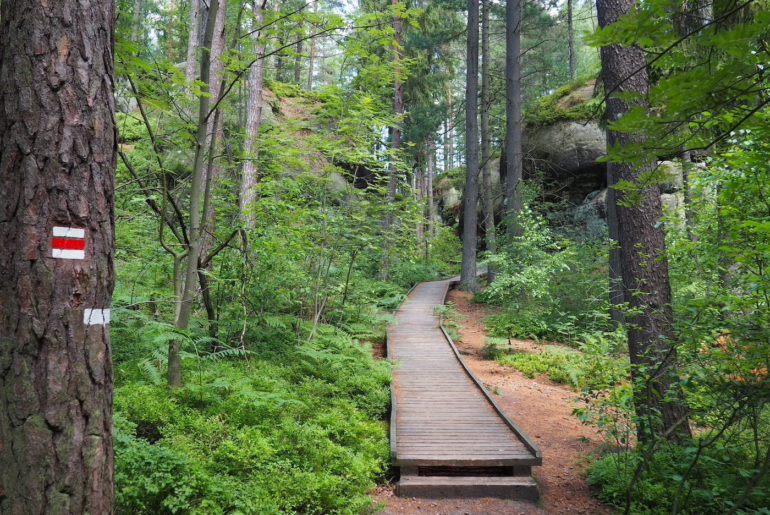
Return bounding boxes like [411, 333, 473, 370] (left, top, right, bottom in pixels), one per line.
[0, 0, 117, 514]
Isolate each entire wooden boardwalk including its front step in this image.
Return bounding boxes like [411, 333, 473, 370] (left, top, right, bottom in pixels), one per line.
[388, 280, 542, 499]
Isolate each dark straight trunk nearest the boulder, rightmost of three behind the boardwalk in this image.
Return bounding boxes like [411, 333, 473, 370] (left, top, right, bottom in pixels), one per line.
[505, 0, 523, 236]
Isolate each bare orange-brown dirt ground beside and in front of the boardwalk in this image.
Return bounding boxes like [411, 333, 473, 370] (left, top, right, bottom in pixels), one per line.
[372, 290, 612, 515]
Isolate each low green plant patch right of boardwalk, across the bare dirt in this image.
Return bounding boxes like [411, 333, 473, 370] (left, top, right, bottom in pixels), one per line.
[486, 335, 628, 390]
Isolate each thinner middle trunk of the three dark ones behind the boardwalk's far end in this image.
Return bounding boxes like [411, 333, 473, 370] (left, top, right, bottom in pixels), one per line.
[481, 0, 497, 282]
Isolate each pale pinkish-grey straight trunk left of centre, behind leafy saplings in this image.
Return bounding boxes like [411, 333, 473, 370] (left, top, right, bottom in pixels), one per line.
[240, 0, 266, 229]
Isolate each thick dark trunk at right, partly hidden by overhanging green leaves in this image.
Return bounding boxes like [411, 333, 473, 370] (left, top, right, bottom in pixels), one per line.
[597, 0, 690, 443]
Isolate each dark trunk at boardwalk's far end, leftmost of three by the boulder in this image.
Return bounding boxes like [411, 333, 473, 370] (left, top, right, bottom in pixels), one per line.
[460, 0, 479, 291]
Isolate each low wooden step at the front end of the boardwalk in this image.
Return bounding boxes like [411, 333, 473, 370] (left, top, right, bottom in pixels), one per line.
[396, 475, 538, 501]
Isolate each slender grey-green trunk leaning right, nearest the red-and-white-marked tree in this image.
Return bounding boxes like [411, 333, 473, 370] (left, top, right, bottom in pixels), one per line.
[168, 0, 219, 388]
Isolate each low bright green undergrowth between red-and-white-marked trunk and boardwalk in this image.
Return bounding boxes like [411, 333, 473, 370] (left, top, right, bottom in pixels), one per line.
[115, 326, 390, 514]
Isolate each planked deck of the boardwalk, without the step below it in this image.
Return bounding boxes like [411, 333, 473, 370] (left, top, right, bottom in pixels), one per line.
[387, 281, 540, 488]
